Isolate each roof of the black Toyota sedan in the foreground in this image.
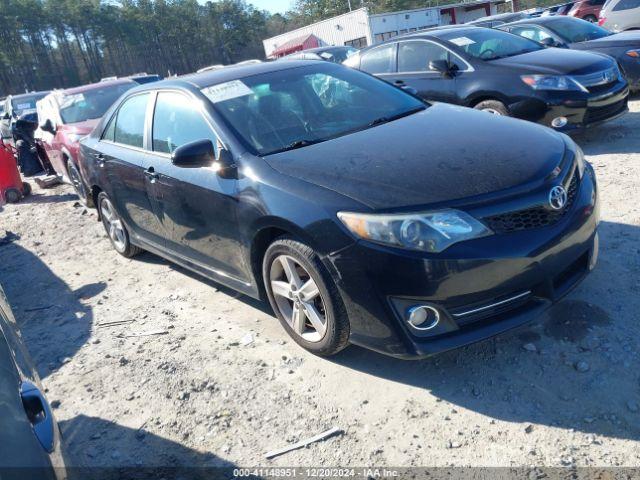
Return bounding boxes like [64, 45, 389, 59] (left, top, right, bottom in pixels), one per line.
[168, 60, 315, 91]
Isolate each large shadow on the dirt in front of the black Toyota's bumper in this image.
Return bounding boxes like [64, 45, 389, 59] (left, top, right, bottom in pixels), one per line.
[329, 222, 640, 440]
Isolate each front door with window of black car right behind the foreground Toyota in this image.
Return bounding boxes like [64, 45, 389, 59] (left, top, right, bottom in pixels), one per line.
[389, 39, 468, 103]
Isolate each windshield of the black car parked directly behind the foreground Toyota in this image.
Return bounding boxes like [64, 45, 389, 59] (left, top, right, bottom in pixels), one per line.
[440, 28, 544, 60]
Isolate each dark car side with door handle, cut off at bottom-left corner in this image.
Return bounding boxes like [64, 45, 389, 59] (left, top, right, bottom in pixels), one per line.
[0, 287, 66, 480]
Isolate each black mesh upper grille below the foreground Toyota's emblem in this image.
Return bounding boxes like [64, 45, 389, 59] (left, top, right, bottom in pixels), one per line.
[484, 169, 579, 234]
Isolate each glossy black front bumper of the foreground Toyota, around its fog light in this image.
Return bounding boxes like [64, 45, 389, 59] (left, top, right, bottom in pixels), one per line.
[329, 166, 598, 359]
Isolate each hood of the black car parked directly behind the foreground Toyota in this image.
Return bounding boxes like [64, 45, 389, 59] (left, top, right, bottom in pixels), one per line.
[488, 48, 612, 75]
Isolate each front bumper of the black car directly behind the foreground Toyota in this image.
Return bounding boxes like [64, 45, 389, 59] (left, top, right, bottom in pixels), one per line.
[509, 81, 629, 132]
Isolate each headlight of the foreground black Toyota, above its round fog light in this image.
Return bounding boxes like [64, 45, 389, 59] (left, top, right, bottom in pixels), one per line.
[338, 210, 493, 253]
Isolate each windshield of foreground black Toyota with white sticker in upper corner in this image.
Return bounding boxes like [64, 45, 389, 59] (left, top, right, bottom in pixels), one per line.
[202, 62, 426, 155]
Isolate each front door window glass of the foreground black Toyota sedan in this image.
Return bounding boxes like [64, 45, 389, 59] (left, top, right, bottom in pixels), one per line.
[153, 92, 216, 153]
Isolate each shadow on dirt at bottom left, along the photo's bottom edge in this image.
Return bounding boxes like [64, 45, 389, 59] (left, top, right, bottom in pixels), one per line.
[59, 415, 241, 480]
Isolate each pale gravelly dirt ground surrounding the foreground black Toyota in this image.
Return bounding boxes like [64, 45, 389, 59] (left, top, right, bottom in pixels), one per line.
[0, 98, 640, 472]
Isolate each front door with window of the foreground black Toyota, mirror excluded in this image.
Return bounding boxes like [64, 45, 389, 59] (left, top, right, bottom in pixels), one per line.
[145, 90, 245, 278]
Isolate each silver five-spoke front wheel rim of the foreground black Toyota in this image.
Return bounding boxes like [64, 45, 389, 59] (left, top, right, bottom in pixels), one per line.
[269, 255, 327, 342]
